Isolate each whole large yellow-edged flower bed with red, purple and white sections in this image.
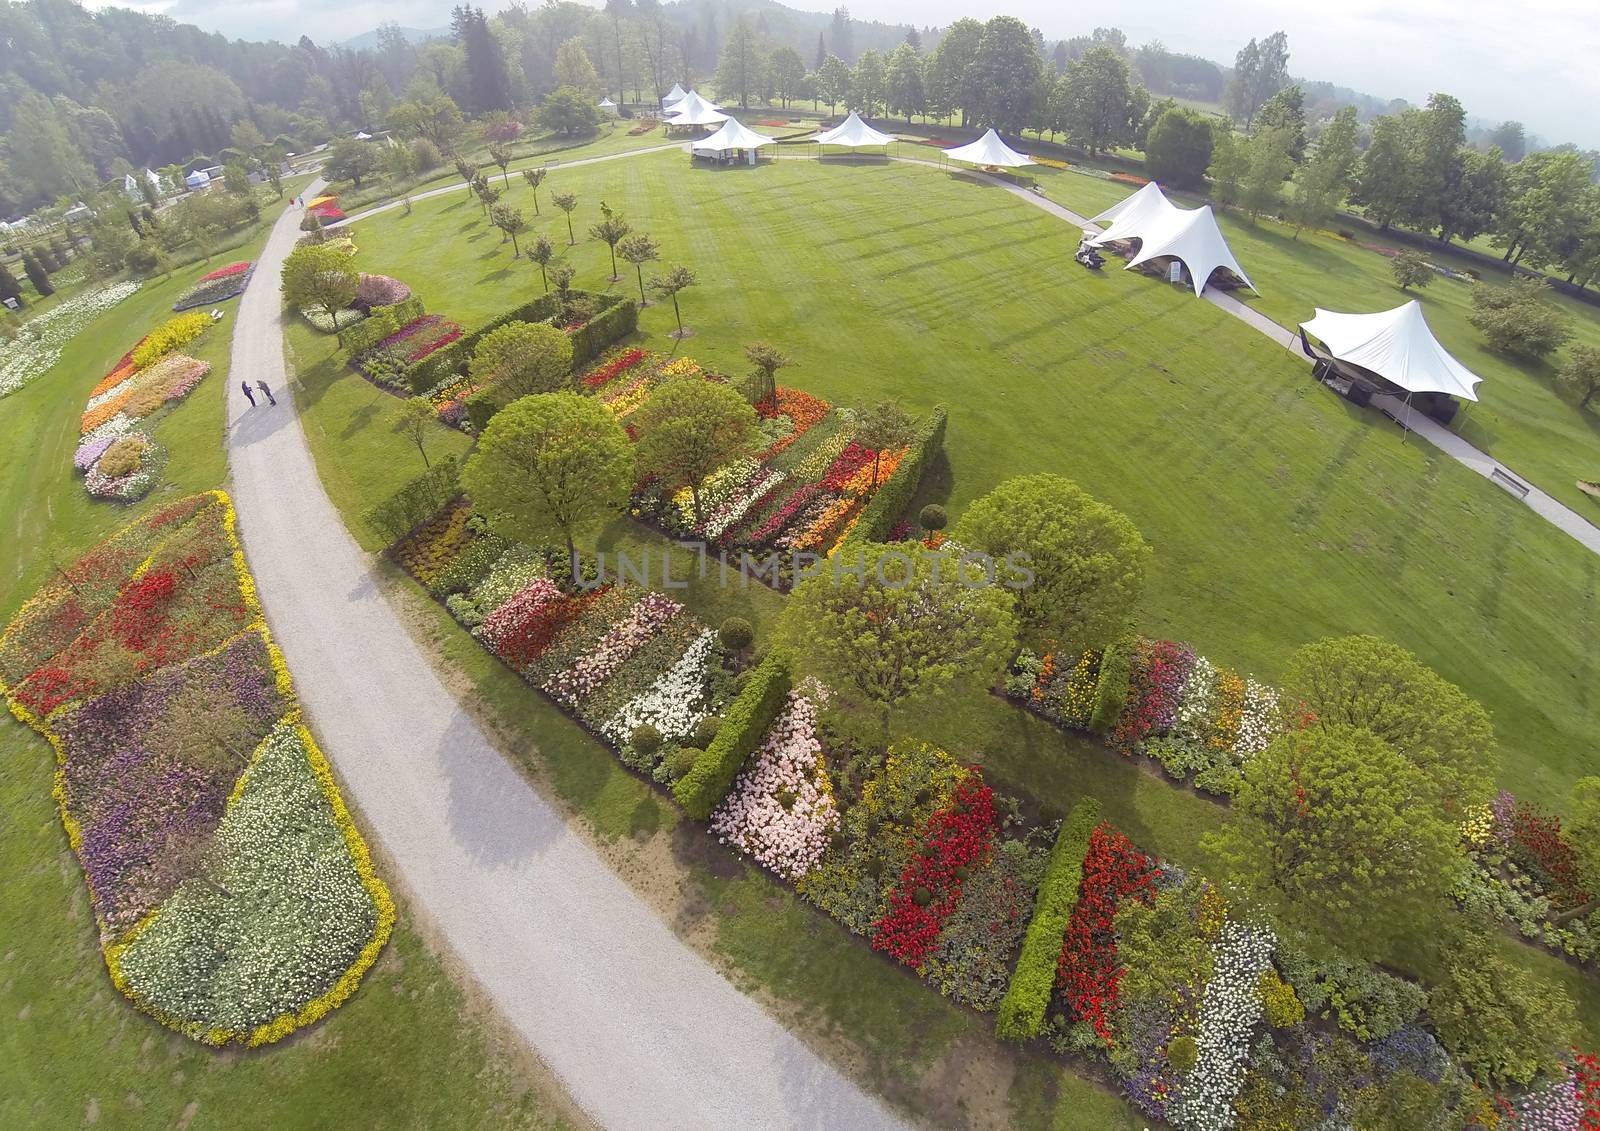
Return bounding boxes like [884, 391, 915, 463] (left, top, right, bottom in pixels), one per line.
[0, 491, 394, 1045]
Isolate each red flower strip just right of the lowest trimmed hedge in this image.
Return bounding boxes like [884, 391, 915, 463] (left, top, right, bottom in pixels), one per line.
[1056, 824, 1155, 1046]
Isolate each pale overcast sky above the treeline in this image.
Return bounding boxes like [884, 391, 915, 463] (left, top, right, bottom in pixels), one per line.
[90, 0, 1600, 147]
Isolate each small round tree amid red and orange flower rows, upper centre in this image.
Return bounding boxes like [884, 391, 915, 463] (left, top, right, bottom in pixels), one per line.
[632, 376, 760, 523]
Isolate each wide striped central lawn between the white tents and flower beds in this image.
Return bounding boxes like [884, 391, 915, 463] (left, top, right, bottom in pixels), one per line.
[340, 154, 1600, 803]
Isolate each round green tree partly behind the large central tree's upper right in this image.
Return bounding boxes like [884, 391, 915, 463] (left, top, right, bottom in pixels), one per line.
[954, 475, 1150, 651]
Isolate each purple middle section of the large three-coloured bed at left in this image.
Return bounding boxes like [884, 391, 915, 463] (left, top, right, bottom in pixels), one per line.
[54, 632, 288, 931]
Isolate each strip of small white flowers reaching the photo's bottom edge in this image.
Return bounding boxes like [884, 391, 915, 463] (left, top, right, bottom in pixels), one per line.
[1176, 920, 1277, 1131]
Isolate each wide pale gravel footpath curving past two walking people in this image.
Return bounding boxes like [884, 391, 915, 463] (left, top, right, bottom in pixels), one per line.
[229, 181, 904, 1131]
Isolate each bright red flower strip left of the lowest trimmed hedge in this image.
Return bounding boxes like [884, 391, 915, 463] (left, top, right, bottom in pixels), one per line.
[872, 769, 995, 969]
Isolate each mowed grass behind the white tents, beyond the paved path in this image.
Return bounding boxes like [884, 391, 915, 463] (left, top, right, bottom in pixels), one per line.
[1040, 164, 1600, 522]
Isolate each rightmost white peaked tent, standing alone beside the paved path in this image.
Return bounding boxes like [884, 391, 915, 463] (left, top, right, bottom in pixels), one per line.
[1301, 299, 1483, 400]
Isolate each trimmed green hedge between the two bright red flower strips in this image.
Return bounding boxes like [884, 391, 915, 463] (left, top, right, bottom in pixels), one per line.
[995, 797, 1099, 1041]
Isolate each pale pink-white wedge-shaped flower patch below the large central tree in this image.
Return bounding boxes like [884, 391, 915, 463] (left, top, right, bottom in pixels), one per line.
[710, 693, 838, 880]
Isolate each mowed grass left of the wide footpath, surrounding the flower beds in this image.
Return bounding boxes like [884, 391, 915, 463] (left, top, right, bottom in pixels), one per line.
[0, 208, 585, 1128]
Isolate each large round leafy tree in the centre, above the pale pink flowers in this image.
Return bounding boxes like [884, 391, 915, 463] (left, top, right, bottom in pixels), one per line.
[776, 542, 1016, 747]
